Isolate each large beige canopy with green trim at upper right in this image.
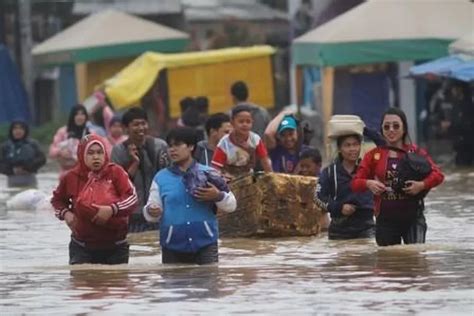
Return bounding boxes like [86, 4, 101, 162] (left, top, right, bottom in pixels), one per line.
[293, 0, 474, 66]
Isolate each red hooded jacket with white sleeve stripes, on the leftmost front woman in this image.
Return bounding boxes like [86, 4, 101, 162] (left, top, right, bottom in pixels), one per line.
[51, 134, 138, 248]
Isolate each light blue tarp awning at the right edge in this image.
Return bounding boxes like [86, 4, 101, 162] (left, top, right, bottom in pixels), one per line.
[410, 55, 474, 82]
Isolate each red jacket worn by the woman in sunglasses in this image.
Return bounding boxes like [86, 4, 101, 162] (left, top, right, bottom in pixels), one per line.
[351, 144, 444, 216]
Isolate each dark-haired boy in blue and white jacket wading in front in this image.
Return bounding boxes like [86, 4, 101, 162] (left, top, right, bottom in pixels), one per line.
[143, 128, 237, 264]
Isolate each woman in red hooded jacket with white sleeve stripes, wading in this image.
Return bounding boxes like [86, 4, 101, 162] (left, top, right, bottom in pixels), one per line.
[51, 134, 138, 264]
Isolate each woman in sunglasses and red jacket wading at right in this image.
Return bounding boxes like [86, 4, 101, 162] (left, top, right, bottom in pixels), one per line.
[351, 108, 444, 246]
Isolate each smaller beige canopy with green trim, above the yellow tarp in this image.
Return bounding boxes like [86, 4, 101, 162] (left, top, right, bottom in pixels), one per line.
[32, 10, 189, 64]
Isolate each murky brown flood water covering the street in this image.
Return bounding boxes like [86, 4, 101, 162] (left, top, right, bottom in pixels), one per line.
[0, 170, 474, 315]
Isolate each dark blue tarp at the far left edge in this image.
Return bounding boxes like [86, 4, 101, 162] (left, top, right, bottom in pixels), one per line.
[0, 44, 30, 124]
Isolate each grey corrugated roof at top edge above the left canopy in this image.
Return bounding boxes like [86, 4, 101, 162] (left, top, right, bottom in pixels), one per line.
[72, 0, 182, 15]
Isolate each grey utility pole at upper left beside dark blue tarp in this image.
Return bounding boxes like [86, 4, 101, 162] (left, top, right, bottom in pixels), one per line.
[18, 0, 36, 123]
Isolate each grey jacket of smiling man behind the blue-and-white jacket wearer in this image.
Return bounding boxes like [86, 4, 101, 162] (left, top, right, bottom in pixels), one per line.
[111, 136, 170, 214]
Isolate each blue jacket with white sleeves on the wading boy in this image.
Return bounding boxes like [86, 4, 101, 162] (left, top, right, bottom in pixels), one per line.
[143, 162, 237, 253]
